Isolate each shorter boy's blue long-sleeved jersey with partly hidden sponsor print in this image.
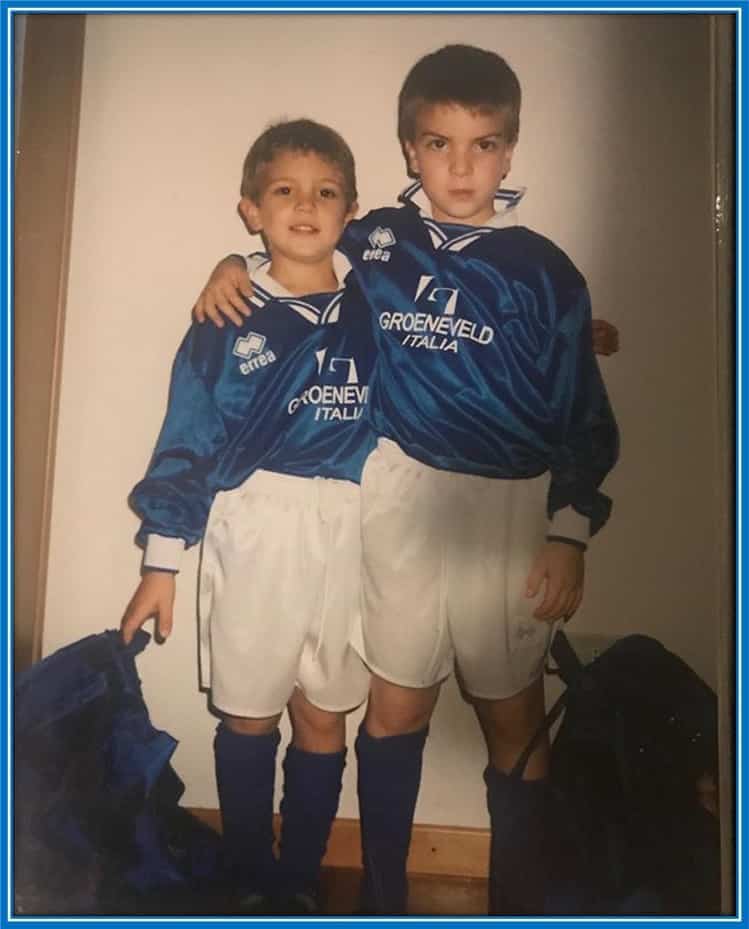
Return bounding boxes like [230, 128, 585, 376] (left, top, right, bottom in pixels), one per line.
[130, 258, 374, 568]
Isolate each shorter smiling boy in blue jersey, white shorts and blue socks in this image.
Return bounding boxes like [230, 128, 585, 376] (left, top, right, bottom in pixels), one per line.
[121, 120, 373, 913]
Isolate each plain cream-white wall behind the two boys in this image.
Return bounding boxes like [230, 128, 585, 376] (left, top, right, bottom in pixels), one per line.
[40, 14, 717, 826]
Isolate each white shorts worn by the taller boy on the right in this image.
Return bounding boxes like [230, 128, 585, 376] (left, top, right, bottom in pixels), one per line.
[355, 439, 551, 699]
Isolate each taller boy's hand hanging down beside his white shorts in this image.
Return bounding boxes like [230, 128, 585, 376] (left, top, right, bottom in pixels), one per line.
[525, 542, 585, 623]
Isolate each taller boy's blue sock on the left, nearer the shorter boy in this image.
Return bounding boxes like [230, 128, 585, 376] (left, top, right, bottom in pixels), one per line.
[356, 723, 429, 916]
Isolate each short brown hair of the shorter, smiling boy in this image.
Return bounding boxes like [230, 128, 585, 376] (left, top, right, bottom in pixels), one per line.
[240, 119, 357, 207]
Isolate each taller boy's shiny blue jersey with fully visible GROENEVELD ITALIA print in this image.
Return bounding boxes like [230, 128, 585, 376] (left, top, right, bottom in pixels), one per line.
[341, 184, 618, 538]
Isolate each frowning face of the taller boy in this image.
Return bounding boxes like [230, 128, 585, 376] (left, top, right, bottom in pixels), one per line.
[405, 103, 515, 226]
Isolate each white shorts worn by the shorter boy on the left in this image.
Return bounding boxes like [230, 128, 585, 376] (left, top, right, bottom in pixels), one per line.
[199, 471, 369, 717]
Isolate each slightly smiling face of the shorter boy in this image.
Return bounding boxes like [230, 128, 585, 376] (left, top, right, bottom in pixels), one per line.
[239, 151, 356, 264]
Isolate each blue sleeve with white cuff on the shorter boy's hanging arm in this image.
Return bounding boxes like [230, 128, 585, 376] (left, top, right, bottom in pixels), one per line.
[130, 326, 228, 571]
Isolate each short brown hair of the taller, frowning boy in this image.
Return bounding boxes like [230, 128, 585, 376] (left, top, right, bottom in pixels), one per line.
[398, 45, 520, 169]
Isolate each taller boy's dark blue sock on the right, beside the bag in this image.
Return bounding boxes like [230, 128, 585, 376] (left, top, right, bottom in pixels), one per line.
[484, 765, 550, 916]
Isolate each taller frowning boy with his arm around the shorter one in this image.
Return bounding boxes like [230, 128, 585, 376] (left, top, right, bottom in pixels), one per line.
[188, 46, 618, 914]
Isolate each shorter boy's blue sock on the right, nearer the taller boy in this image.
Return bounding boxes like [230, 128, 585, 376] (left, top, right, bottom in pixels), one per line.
[280, 745, 346, 898]
